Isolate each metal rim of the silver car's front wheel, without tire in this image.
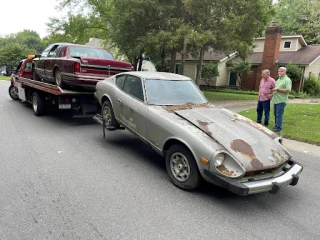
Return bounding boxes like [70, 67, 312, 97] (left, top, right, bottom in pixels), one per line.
[170, 153, 190, 182]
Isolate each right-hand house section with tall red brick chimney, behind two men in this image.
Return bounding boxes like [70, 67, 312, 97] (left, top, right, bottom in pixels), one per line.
[233, 24, 320, 90]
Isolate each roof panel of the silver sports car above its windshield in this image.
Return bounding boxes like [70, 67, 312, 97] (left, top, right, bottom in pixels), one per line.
[122, 71, 191, 80]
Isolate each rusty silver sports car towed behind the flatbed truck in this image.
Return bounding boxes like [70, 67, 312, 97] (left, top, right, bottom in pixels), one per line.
[95, 72, 303, 195]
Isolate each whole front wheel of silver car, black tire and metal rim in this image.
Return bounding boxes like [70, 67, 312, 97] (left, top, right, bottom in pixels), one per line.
[166, 144, 201, 190]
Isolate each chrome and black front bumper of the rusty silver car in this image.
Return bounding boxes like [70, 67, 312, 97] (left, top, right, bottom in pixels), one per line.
[204, 161, 303, 196]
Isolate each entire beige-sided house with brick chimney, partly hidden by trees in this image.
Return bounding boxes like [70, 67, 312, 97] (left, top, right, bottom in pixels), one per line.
[176, 24, 320, 90]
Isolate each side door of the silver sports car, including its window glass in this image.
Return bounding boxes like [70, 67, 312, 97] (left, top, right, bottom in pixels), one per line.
[116, 75, 148, 139]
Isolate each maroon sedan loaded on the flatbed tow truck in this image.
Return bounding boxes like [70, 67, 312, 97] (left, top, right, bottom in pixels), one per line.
[33, 43, 133, 90]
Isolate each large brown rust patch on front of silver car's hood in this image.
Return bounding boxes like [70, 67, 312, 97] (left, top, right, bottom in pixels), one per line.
[230, 139, 263, 170]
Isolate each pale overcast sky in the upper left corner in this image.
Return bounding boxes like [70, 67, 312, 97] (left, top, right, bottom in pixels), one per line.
[0, 0, 63, 38]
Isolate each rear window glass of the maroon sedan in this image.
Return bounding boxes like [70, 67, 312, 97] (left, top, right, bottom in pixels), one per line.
[69, 46, 114, 60]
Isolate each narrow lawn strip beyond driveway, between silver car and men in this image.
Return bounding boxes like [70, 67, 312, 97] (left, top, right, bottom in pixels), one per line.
[203, 91, 258, 101]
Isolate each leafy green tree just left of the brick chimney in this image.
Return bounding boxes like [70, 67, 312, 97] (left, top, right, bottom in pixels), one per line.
[184, 0, 273, 82]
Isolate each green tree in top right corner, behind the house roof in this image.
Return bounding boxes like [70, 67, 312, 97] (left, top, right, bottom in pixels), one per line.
[274, 0, 320, 44]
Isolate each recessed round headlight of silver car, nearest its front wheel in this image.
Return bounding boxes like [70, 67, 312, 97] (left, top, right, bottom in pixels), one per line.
[210, 151, 246, 178]
